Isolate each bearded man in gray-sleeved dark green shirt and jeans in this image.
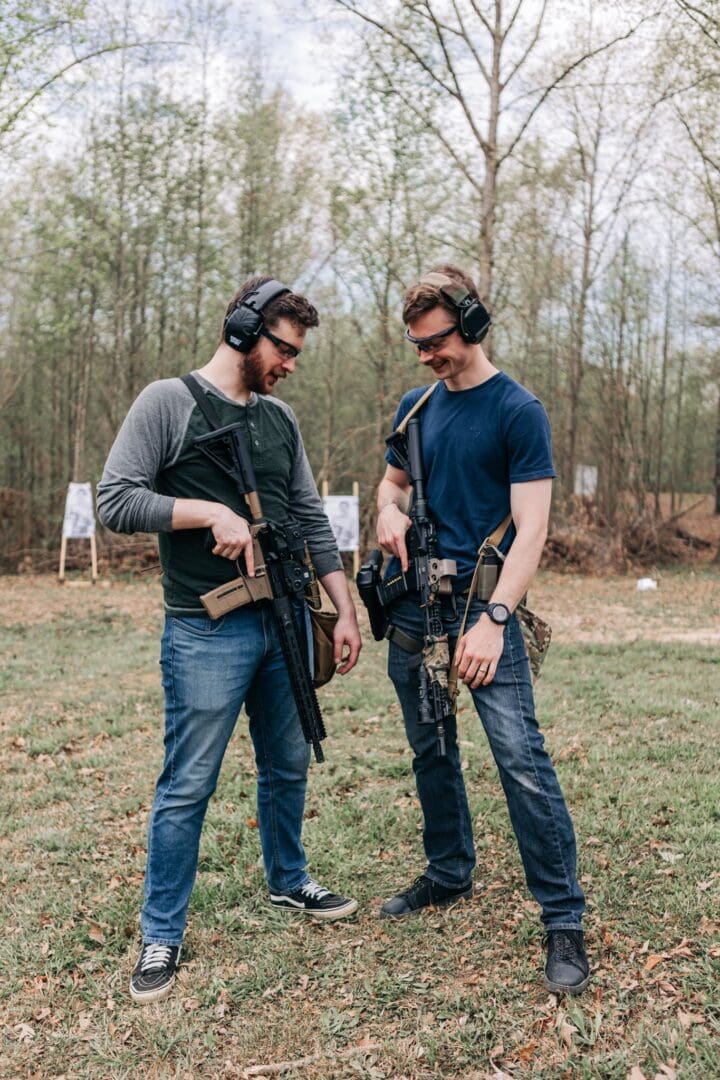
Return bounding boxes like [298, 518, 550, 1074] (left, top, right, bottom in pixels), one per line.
[98, 276, 361, 1003]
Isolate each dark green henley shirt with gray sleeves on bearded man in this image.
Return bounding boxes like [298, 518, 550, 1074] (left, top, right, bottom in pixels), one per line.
[97, 372, 342, 613]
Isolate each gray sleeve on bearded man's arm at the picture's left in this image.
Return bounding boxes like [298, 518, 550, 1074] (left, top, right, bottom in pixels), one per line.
[97, 381, 193, 532]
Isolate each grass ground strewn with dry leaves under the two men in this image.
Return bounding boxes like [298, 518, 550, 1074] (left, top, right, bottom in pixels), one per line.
[0, 570, 720, 1080]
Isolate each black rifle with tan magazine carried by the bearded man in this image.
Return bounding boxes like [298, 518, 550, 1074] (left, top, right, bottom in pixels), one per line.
[194, 423, 327, 761]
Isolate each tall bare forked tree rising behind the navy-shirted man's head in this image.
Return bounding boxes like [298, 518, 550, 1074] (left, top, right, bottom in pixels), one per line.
[335, 0, 650, 330]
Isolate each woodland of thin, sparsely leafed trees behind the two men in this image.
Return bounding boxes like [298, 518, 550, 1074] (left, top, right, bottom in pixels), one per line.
[0, 2, 720, 570]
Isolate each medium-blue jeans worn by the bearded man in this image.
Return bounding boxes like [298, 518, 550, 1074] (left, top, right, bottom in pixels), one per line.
[141, 605, 310, 945]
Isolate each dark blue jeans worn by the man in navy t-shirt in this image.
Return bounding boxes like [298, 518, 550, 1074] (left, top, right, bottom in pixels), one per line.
[389, 597, 585, 929]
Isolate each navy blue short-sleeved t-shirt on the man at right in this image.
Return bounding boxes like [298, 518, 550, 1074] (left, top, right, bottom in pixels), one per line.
[385, 372, 556, 589]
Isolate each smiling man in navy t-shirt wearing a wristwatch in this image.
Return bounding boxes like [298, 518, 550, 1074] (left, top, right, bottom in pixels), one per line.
[378, 265, 589, 994]
